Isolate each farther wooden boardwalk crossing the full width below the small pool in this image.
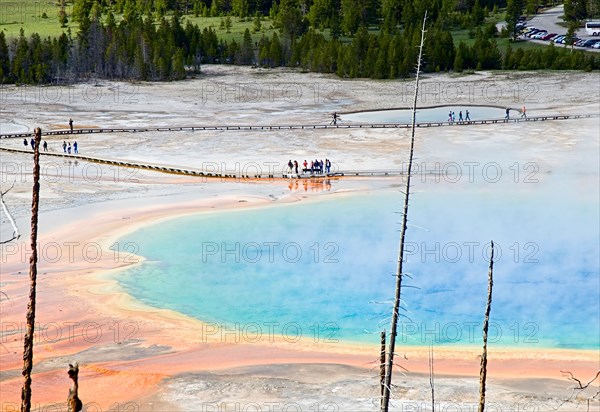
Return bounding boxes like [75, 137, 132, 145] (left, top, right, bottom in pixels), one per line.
[0, 114, 600, 139]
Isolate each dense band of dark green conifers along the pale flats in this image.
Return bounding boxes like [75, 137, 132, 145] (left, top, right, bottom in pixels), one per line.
[0, 0, 600, 84]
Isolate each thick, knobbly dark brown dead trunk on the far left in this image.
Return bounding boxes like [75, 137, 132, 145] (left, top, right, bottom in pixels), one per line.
[21, 127, 42, 412]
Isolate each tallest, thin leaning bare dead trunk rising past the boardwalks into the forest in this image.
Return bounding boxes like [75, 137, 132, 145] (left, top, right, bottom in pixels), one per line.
[381, 11, 427, 412]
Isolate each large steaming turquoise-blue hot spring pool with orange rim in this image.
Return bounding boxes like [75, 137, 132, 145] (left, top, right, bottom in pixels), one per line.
[113, 191, 600, 349]
